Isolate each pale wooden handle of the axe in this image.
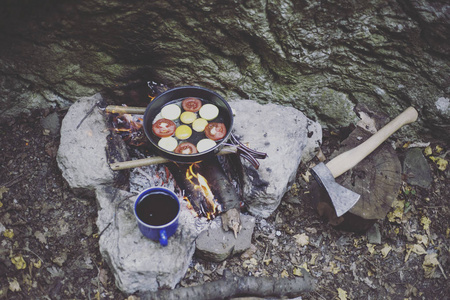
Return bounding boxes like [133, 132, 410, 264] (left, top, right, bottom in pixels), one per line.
[326, 107, 418, 178]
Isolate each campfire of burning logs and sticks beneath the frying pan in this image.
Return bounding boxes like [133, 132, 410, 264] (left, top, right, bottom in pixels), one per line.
[106, 84, 265, 229]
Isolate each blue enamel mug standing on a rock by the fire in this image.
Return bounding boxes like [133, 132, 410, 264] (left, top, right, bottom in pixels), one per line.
[134, 187, 180, 246]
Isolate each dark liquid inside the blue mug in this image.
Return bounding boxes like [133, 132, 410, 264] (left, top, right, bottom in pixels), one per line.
[136, 193, 179, 226]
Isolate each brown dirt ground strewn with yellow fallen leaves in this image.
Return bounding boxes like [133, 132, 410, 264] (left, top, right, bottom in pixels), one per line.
[0, 111, 450, 299]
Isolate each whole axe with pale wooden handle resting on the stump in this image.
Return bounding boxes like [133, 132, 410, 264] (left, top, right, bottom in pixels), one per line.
[312, 107, 418, 217]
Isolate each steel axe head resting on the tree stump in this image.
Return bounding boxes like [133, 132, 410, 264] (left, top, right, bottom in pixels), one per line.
[312, 163, 360, 217]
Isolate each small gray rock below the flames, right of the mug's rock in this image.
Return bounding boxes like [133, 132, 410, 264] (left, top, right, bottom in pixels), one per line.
[196, 214, 256, 262]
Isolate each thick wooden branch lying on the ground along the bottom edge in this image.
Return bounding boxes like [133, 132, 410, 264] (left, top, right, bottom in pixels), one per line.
[140, 270, 315, 300]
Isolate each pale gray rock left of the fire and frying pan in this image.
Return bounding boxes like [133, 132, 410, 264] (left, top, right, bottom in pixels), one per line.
[56, 94, 117, 190]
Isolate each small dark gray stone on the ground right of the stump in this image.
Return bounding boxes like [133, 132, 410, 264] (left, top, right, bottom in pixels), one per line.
[403, 148, 433, 189]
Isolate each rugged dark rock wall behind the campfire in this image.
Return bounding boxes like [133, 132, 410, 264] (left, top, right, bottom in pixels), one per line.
[0, 0, 450, 137]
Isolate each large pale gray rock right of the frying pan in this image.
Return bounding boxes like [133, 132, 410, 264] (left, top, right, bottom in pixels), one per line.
[230, 100, 322, 218]
